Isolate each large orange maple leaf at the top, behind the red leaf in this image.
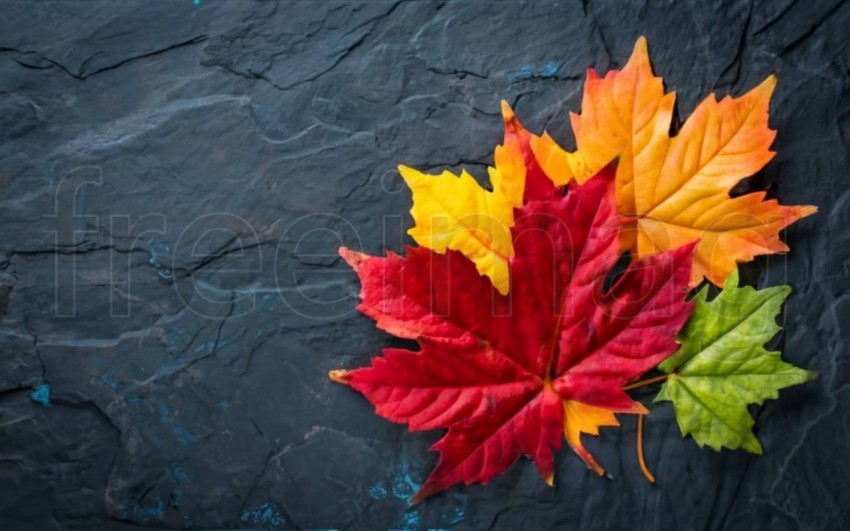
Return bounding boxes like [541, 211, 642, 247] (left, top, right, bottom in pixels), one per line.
[530, 37, 817, 286]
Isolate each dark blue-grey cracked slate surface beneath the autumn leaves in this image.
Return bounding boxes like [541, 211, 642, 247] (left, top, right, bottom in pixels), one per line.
[0, 0, 850, 530]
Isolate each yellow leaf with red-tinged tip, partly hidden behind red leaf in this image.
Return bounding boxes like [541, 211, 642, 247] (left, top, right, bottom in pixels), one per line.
[399, 101, 566, 295]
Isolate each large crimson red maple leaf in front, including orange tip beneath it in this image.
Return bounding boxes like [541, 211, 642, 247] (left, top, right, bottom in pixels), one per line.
[330, 166, 693, 501]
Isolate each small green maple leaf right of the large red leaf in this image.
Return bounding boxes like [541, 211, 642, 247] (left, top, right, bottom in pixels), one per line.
[655, 270, 816, 454]
